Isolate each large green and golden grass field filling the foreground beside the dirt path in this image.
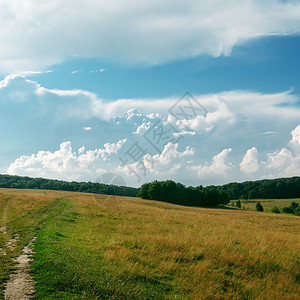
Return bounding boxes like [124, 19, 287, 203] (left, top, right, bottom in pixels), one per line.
[0, 189, 300, 299]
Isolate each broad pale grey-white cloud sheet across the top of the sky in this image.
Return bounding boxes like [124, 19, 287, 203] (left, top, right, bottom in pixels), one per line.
[0, 0, 300, 72]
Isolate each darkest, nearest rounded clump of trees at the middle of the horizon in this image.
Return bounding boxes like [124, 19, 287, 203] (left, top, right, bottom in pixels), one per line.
[137, 180, 229, 206]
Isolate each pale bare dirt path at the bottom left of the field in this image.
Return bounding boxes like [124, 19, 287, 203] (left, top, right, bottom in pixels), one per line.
[4, 237, 36, 300]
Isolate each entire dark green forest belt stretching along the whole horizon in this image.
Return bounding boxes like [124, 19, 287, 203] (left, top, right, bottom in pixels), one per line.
[0, 175, 300, 206]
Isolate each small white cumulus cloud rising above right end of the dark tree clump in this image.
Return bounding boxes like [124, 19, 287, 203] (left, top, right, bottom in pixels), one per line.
[189, 148, 233, 178]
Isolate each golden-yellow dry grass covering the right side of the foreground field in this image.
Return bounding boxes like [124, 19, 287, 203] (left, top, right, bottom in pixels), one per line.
[71, 196, 300, 299]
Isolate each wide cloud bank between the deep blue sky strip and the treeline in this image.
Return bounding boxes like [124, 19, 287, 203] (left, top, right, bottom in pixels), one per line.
[0, 74, 300, 185]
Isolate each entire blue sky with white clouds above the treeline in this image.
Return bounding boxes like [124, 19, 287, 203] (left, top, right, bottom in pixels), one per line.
[0, 0, 300, 187]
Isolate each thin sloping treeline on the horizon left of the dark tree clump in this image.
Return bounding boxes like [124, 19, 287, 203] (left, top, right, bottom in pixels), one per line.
[0, 175, 138, 197]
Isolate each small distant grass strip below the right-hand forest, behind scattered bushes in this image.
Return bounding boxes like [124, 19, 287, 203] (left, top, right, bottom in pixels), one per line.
[232, 198, 300, 211]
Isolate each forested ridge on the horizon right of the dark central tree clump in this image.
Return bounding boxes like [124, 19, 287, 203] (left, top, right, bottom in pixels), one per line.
[209, 177, 300, 200]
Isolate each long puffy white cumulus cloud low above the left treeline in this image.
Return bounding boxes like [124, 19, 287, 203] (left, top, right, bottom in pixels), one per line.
[7, 139, 126, 180]
